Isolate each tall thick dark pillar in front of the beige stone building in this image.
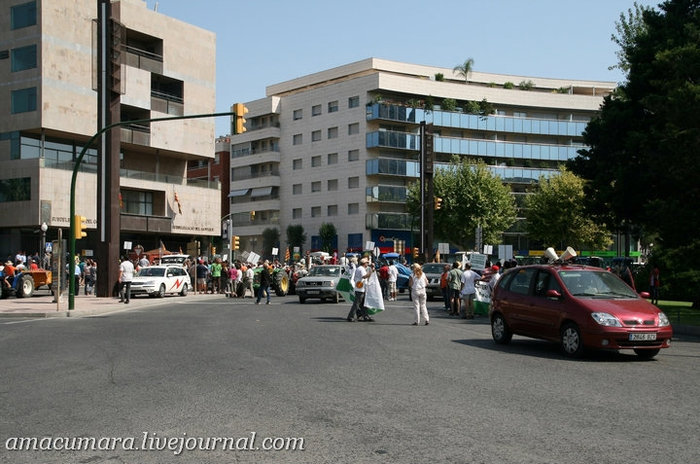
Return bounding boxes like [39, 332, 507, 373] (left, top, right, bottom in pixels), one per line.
[95, 0, 126, 297]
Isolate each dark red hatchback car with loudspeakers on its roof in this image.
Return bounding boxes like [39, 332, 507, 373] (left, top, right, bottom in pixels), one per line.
[489, 264, 673, 359]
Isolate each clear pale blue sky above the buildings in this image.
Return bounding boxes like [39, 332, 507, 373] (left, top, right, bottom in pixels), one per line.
[146, 0, 659, 136]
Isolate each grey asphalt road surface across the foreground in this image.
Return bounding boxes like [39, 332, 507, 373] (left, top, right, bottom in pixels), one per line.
[0, 296, 700, 464]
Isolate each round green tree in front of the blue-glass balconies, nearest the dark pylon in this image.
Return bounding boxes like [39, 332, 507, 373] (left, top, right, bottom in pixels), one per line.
[407, 156, 516, 250]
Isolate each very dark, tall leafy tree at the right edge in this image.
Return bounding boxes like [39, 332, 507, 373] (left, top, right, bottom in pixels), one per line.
[569, 0, 700, 247]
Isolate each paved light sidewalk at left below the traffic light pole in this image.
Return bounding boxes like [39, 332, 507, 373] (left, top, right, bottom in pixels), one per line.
[0, 290, 225, 318]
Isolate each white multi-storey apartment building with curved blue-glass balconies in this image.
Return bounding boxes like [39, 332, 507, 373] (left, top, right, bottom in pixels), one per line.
[230, 58, 615, 253]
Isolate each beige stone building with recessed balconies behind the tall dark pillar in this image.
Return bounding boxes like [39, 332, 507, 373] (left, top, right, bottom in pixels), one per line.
[0, 0, 221, 256]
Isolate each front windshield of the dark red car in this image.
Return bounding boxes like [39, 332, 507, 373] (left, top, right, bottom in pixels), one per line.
[559, 270, 637, 298]
